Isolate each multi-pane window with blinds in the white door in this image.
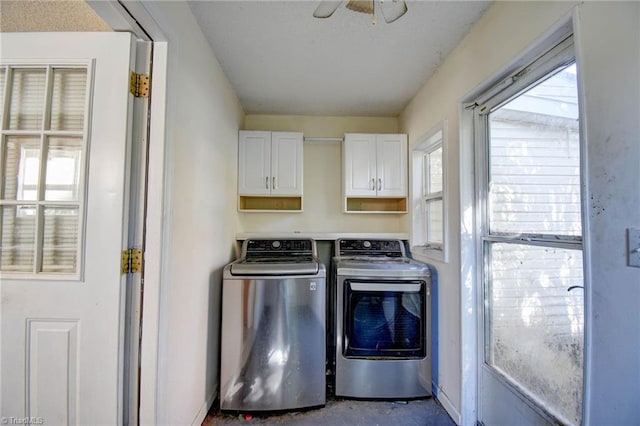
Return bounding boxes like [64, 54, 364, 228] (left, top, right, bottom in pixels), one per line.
[0, 65, 90, 277]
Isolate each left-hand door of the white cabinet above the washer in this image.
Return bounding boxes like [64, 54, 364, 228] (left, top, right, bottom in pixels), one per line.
[238, 131, 271, 195]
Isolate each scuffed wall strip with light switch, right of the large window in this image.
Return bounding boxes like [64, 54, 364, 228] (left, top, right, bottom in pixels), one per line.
[576, 2, 640, 425]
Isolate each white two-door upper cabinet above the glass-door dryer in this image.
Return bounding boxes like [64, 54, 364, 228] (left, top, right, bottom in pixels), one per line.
[344, 133, 407, 197]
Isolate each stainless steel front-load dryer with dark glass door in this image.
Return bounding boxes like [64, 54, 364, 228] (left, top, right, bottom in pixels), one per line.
[333, 239, 431, 399]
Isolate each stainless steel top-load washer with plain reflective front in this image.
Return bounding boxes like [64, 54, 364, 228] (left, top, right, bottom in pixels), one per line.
[220, 239, 326, 412]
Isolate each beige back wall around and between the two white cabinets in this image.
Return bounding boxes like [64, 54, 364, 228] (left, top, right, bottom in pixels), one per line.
[238, 115, 407, 233]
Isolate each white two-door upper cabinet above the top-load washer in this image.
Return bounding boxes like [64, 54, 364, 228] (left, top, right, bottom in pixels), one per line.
[238, 130, 303, 196]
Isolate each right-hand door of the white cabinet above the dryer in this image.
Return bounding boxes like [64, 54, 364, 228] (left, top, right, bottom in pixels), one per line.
[376, 135, 407, 197]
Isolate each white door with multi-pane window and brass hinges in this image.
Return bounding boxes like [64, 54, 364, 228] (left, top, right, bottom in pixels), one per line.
[0, 33, 135, 424]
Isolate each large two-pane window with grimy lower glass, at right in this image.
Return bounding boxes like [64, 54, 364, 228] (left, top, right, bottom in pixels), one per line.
[474, 37, 584, 424]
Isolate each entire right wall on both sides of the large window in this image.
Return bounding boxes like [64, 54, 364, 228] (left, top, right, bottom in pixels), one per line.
[400, 2, 640, 424]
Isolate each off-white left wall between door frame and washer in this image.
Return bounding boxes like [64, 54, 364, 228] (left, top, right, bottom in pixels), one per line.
[136, 2, 244, 425]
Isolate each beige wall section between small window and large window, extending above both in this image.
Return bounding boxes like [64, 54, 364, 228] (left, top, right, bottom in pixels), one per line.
[399, 2, 573, 420]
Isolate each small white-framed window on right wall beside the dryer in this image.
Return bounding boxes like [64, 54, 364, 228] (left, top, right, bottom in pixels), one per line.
[412, 122, 446, 261]
